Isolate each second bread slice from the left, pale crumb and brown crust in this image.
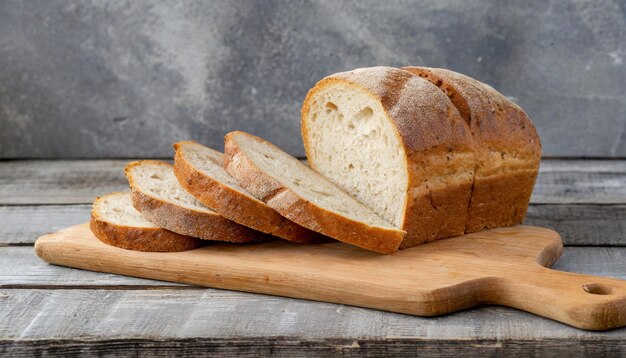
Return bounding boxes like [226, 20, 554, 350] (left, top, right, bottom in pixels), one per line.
[125, 160, 264, 243]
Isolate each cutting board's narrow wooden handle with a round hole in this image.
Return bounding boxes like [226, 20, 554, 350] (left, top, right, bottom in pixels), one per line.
[500, 264, 626, 330]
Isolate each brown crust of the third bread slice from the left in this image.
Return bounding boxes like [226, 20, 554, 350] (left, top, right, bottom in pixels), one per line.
[174, 141, 320, 243]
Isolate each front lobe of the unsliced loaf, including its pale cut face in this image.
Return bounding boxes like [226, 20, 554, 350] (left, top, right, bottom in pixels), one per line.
[302, 67, 476, 248]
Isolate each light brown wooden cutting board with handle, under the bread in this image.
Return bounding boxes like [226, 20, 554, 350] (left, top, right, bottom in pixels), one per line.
[35, 224, 626, 330]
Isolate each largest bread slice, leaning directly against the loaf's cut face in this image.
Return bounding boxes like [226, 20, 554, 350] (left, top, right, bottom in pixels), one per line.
[224, 132, 404, 254]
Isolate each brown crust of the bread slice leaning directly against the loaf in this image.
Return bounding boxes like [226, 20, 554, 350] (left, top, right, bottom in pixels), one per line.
[224, 131, 404, 254]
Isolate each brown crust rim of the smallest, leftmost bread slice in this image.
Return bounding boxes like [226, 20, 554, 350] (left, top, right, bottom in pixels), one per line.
[89, 193, 202, 252]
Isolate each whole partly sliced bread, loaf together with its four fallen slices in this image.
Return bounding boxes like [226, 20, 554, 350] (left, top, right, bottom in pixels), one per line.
[91, 67, 541, 254]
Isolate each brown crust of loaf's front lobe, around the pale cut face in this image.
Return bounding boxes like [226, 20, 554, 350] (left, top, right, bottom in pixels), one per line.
[302, 67, 475, 248]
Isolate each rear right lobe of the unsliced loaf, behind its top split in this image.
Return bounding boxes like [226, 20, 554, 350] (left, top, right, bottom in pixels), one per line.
[403, 67, 541, 233]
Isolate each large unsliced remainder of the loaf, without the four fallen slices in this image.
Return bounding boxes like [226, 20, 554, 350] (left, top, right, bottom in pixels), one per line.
[302, 67, 540, 248]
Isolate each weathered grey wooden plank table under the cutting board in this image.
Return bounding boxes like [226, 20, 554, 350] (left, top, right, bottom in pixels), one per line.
[0, 159, 626, 357]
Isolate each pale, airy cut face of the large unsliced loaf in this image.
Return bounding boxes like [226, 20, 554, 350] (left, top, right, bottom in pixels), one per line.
[302, 82, 408, 227]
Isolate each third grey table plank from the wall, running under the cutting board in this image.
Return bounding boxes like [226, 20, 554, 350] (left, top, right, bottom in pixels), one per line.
[0, 246, 626, 288]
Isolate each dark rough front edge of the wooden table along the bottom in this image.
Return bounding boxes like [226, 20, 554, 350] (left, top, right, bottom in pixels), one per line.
[0, 337, 626, 358]
